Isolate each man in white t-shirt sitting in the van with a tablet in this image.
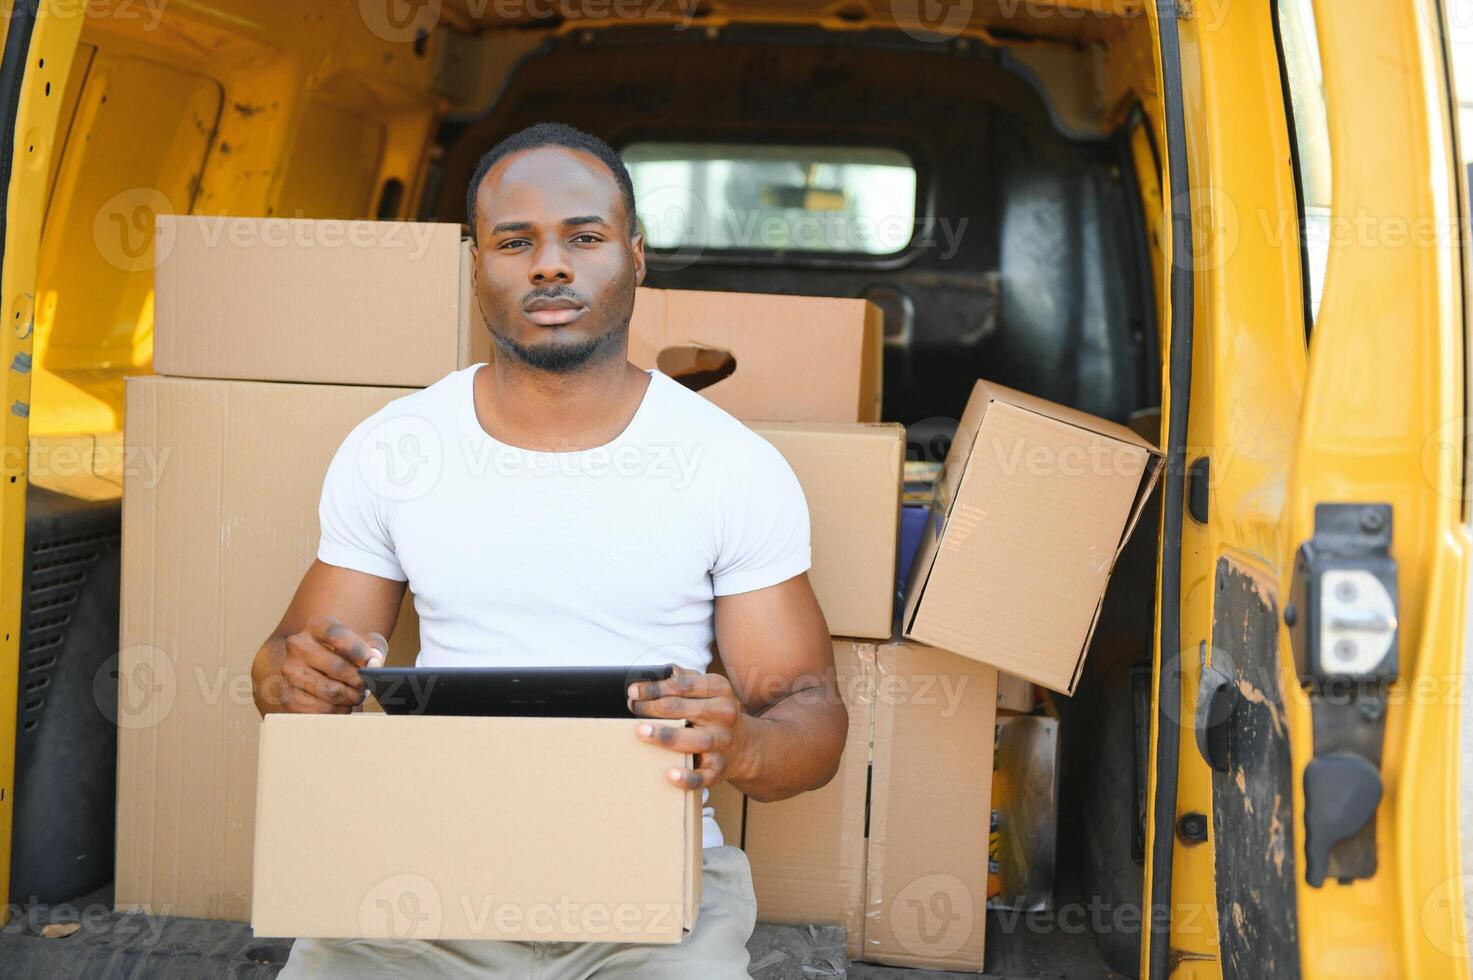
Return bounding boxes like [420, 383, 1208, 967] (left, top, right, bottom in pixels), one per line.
[252, 124, 847, 979]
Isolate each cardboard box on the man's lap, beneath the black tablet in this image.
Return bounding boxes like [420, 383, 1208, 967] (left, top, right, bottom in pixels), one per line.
[250, 713, 701, 943]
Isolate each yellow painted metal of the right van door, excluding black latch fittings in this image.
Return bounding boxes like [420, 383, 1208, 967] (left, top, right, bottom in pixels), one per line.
[1147, 0, 1469, 977]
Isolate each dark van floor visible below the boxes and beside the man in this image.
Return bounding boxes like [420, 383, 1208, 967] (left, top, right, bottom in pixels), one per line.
[0, 886, 1119, 980]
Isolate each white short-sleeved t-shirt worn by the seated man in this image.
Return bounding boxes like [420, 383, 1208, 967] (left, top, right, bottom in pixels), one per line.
[317, 364, 810, 847]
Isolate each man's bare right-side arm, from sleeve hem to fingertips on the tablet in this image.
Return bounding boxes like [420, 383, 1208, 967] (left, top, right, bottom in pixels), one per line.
[630, 575, 848, 802]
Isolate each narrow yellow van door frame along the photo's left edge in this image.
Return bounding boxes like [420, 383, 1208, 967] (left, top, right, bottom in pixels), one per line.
[0, 3, 82, 923]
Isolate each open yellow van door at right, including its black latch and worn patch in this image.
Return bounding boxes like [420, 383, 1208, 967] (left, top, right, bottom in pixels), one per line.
[1142, 0, 1473, 977]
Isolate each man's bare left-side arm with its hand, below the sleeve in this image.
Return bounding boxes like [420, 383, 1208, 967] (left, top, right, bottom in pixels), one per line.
[250, 561, 405, 715]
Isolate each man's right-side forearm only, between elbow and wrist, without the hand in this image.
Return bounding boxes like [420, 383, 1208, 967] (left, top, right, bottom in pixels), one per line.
[726, 687, 848, 803]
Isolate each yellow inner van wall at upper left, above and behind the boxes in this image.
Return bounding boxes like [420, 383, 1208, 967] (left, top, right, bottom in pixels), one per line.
[32, 0, 445, 433]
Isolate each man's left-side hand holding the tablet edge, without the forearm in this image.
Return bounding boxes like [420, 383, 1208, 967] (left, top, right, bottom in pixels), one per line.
[278, 615, 389, 715]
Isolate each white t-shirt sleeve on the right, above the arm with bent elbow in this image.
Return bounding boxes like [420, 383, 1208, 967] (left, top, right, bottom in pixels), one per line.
[711, 439, 812, 595]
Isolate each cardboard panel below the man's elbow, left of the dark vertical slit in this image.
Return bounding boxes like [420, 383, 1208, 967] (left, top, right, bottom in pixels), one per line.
[745, 640, 875, 959]
